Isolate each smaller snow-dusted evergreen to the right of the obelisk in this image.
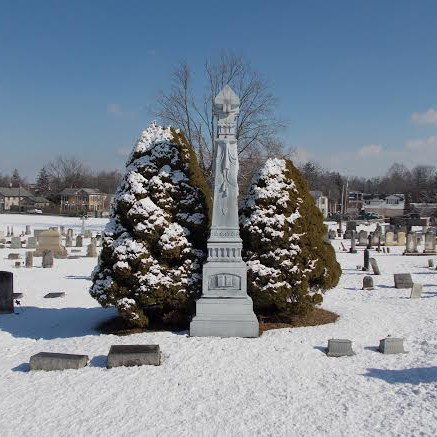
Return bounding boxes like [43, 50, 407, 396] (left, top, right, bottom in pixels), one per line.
[240, 159, 341, 314]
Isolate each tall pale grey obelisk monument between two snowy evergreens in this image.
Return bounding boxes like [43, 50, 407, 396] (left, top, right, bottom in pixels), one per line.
[190, 85, 259, 337]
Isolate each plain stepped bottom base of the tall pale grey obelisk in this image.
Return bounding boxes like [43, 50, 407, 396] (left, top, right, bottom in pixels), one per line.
[190, 296, 259, 337]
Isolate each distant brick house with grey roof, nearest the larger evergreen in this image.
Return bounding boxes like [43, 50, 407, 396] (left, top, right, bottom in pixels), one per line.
[59, 188, 107, 213]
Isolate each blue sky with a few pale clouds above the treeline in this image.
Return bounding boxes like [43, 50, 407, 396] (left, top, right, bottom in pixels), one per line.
[0, 0, 437, 180]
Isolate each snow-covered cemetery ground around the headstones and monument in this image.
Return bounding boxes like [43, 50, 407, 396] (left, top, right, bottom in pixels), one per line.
[0, 215, 437, 436]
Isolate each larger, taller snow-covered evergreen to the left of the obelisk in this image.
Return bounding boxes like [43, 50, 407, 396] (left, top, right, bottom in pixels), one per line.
[90, 123, 211, 327]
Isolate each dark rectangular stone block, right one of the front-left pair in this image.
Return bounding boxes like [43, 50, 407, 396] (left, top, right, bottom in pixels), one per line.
[106, 344, 161, 369]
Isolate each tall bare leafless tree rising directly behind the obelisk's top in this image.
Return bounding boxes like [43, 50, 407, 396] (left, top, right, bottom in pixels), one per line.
[152, 52, 284, 185]
